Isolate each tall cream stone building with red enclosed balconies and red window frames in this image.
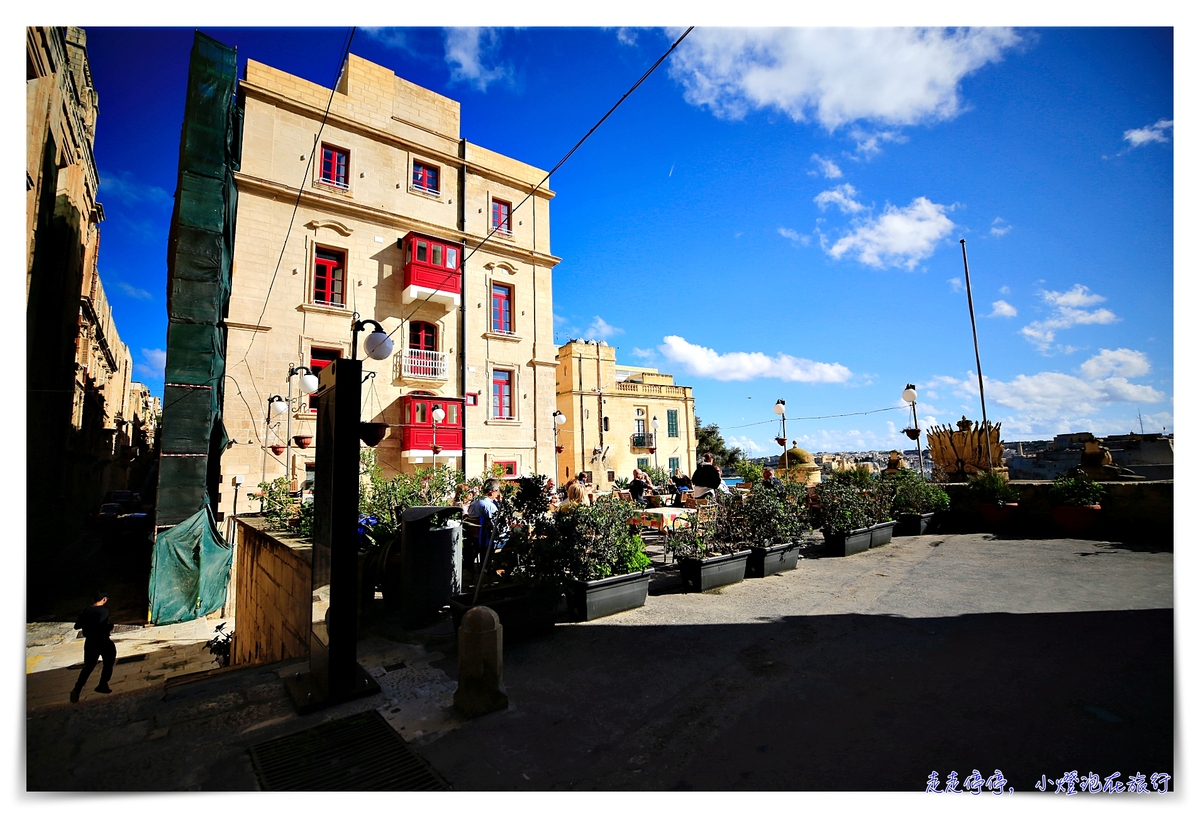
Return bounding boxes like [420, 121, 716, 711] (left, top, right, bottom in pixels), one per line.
[220, 55, 559, 511]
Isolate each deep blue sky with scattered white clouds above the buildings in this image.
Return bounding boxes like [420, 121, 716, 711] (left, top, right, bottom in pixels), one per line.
[79, 25, 1175, 455]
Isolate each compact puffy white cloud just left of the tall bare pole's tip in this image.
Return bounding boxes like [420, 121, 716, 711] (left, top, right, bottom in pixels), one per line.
[827, 196, 954, 270]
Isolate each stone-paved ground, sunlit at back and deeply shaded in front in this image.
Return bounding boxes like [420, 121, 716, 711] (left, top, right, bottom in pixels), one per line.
[26, 534, 1175, 792]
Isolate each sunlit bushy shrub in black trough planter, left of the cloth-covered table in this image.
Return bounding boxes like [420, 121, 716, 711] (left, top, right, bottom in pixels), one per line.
[552, 494, 654, 621]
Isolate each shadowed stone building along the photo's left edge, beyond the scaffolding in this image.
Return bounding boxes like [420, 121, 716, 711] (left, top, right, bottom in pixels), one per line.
[25, 26, 147, 577]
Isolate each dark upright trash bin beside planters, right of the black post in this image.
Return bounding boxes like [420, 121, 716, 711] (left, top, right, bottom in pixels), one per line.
[389, 506, 462, 628]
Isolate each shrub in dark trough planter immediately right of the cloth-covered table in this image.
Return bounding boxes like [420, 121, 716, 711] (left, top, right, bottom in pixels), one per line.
[666, 495, 750, 591]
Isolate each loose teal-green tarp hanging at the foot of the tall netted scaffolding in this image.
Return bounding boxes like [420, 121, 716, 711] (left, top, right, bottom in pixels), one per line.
[150, 506, 233, 625]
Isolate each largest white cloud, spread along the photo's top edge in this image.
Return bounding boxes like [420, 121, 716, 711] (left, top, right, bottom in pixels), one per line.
[670, 28, 1020, 131]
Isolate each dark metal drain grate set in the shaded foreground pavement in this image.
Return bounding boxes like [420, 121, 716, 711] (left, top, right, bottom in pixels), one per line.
[250, 710, 450, 792]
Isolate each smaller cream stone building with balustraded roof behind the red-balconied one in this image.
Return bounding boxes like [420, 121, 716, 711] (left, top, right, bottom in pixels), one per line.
[554, 341, 696, 491]
